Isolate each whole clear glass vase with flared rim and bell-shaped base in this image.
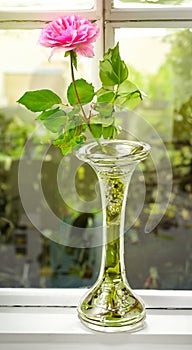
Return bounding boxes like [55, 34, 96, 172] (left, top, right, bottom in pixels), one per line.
[77, 140, 150, 332]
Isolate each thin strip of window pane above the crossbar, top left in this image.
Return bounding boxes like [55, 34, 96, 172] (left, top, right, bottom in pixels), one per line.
[0, 0, 95, 10]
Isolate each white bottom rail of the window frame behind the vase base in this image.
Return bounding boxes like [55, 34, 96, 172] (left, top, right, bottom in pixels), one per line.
[0, 288, 192, 310]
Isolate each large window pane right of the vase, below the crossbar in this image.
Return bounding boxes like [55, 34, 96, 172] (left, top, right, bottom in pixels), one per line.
[115, 28, 192, 289]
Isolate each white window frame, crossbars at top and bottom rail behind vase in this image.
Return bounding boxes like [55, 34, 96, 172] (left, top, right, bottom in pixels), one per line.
[0, 0, 192, 310]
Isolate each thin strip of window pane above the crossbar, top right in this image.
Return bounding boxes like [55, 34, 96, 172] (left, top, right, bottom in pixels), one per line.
[113, 0, 192, 8]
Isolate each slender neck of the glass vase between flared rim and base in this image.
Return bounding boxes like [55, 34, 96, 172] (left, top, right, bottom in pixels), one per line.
[98, 165, 135, 280]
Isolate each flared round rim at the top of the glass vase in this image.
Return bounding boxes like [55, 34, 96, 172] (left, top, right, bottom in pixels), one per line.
[77, 140, 151, 165]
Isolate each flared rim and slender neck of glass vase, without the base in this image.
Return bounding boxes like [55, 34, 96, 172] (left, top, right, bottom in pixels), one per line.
[77, 140, 150, 280]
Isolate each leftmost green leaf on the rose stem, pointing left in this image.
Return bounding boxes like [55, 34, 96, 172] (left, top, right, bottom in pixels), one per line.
[17, 89, 62, 112]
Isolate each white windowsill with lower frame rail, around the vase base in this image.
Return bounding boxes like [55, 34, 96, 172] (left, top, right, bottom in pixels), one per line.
[0, 289, 192, 350]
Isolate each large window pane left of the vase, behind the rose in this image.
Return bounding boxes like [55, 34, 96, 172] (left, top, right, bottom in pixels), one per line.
[0, 30, 100, 288]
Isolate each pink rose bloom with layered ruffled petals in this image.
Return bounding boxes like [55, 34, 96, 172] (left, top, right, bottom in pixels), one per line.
[39, 15, 99, 57]
